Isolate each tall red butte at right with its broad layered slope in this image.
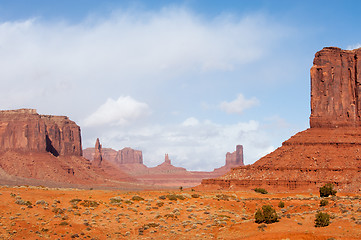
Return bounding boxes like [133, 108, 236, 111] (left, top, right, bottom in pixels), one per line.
[199, 47, 361, 192]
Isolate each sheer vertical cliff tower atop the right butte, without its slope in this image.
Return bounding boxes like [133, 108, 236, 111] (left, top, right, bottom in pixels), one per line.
[310, 47, 361, 128]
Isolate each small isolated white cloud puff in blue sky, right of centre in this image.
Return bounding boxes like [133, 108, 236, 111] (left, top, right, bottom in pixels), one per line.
[219, 94, 259, 114]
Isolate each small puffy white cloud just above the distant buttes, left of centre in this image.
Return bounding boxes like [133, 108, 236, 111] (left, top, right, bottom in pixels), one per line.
[84, 96, 150, 127]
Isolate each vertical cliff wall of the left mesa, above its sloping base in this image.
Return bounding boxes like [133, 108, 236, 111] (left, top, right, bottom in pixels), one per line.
[0, 109, 82, 156]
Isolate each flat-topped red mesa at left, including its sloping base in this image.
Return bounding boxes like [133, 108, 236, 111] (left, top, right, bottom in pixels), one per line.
[0, 109, 136, 187]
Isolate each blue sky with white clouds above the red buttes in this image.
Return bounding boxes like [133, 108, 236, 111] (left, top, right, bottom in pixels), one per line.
[0, 0, 361, 171]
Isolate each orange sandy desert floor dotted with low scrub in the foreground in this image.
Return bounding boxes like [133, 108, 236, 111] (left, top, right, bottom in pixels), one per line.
[0, 186, 361, 240]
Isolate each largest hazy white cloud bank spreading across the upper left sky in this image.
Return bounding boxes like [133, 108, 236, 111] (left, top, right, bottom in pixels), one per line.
[0, 8, 284, 118]
